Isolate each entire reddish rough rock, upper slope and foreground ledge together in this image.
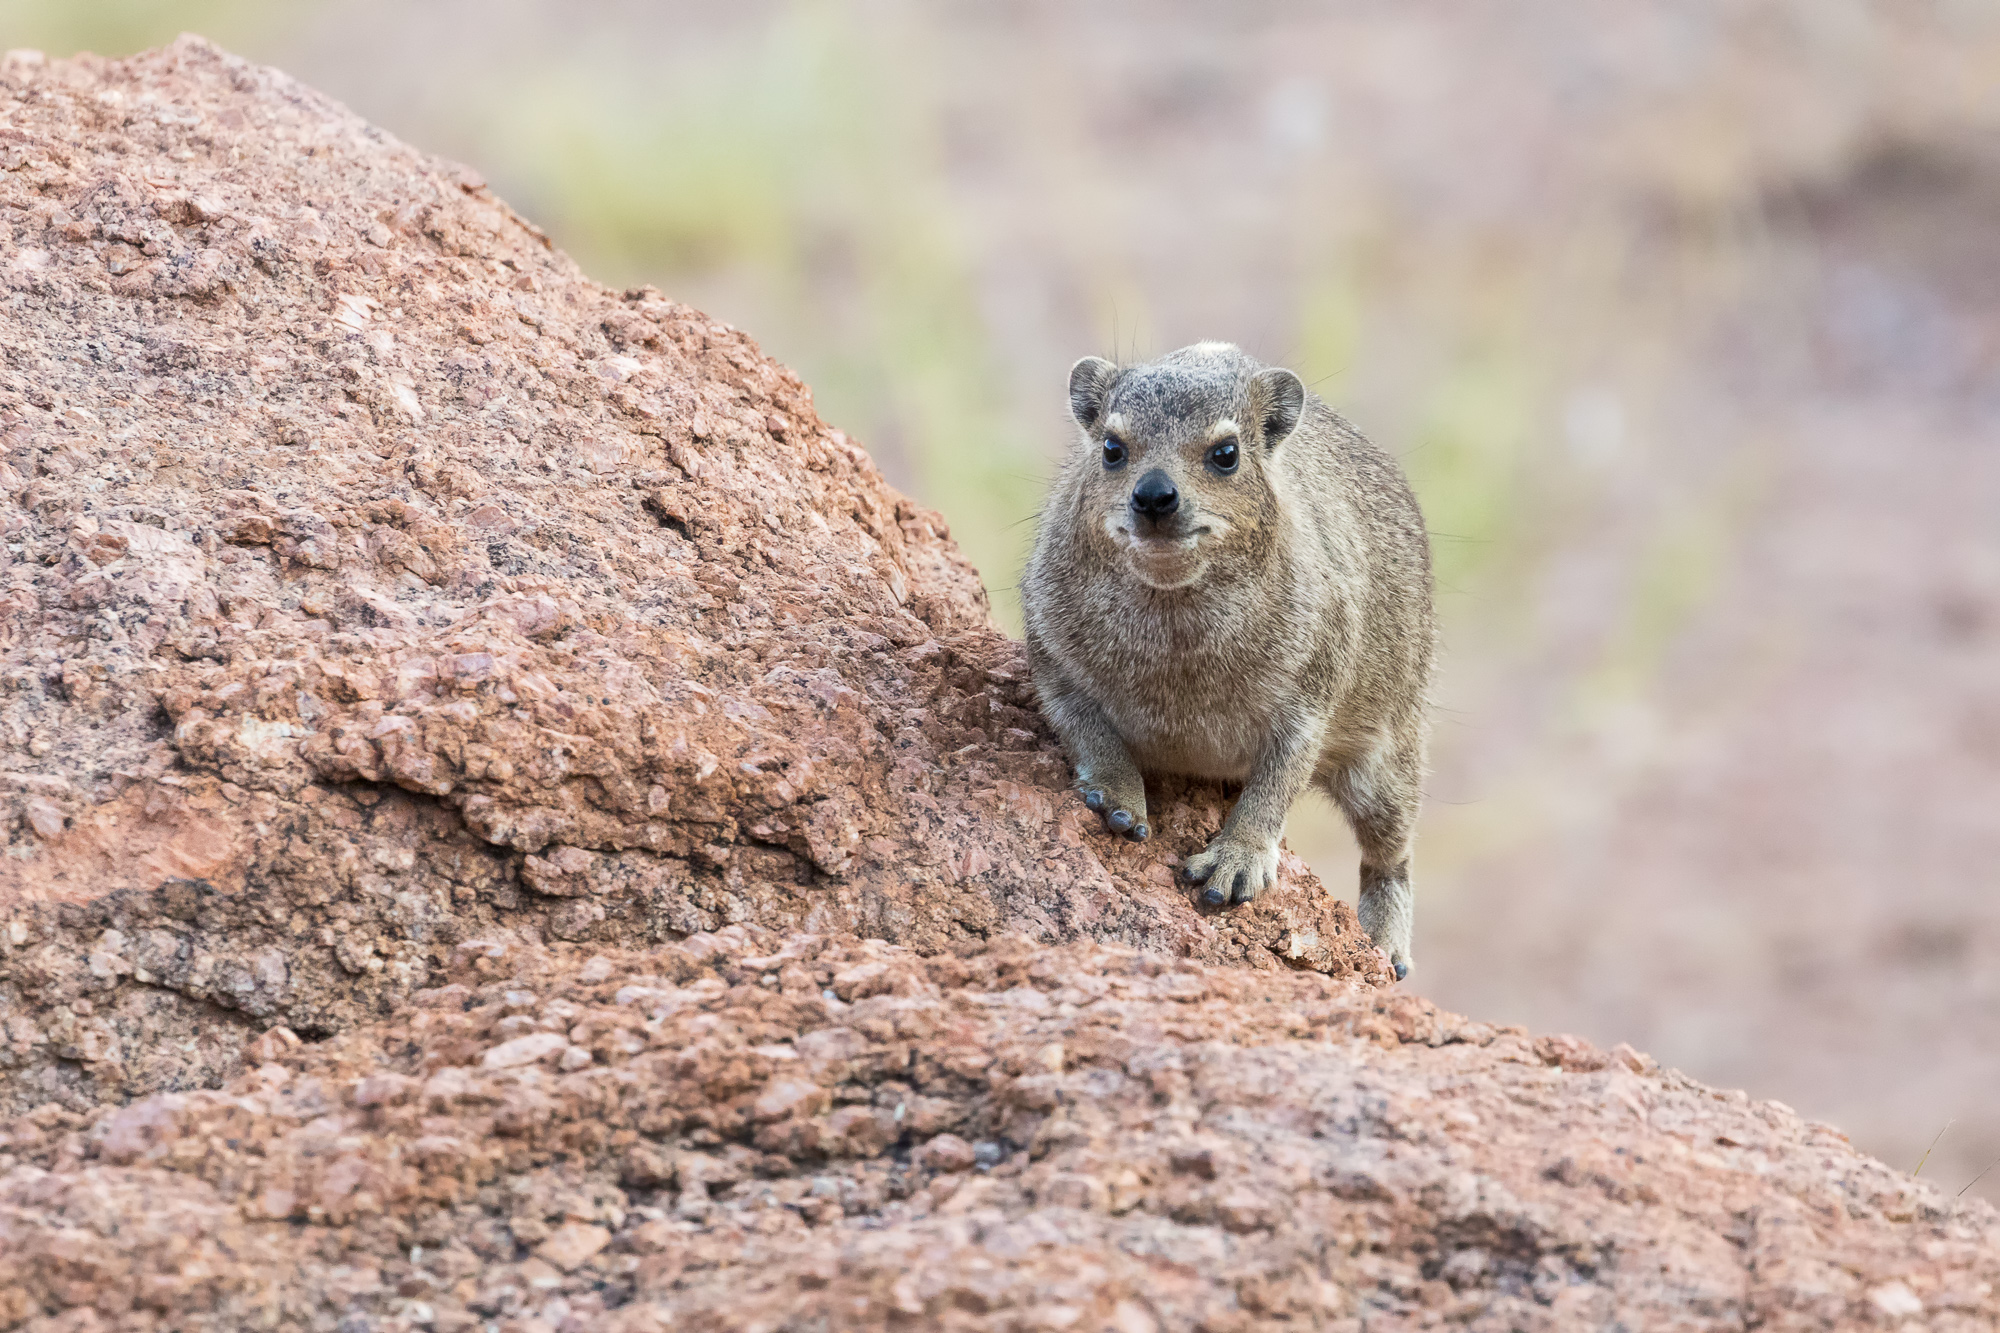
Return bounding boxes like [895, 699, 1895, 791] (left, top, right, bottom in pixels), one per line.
[0, 42, 2000, 1333]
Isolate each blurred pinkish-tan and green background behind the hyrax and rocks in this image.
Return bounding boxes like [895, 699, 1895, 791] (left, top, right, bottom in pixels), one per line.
[15, 0, 2000, 1201]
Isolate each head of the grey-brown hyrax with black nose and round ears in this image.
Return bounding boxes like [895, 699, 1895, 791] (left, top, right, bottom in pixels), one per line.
[1070, 342, 1306, 588]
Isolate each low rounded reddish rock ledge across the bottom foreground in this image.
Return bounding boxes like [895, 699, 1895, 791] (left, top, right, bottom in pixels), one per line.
[0, 927, 2000, 1333]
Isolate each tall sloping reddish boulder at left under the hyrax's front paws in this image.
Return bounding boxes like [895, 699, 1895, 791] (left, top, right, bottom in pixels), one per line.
[0, 40, 1380, 1109]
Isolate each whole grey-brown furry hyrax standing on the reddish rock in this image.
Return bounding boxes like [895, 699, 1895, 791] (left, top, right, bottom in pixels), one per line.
[1022, 342, 1434, 977]
